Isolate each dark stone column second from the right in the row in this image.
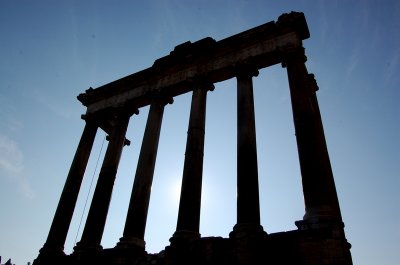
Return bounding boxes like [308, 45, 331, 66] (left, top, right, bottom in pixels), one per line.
[233, 66, 263, 233]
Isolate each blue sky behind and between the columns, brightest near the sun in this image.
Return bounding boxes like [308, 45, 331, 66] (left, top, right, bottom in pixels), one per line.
[0, 0, 400, 265]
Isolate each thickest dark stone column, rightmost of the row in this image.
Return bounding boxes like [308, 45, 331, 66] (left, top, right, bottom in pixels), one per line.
[283, 47, 342, 225]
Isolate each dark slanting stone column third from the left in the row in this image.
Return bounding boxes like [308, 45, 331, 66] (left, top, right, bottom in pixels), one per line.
[117, 96, 173, 249]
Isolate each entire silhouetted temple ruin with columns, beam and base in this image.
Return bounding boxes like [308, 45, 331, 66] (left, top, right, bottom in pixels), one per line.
[34, 12, 352, 265]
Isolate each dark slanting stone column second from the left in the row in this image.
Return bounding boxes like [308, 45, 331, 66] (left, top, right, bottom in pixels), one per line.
[74, 113, 130, 253]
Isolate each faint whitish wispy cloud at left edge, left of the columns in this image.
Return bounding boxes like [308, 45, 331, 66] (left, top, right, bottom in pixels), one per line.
[0, 134, 34, 198]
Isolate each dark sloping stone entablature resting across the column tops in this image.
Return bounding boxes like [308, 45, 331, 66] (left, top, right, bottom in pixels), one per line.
[78, 12, 310, 114]
